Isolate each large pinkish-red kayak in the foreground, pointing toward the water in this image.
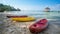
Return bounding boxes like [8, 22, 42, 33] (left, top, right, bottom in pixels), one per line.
[29, 19, 48, 33]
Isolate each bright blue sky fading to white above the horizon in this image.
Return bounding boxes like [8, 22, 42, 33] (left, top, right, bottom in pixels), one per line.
[0, 0, 60, 10]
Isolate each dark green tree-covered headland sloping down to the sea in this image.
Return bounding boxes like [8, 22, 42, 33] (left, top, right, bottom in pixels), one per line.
[0, 4, 21, 12]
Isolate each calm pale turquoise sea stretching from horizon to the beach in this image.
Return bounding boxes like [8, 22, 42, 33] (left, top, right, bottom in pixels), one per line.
[4, 10, 60, 19]
